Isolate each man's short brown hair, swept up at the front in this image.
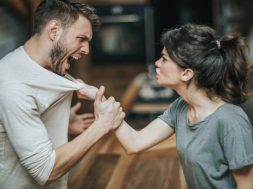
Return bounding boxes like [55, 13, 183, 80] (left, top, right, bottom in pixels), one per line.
[33, 0, 100, 34]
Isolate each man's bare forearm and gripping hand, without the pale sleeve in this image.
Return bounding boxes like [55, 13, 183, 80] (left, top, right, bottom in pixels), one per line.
[46, 87, 125, 185]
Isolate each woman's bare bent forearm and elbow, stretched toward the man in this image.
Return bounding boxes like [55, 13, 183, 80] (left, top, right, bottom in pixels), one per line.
[115, 118, 174, 153]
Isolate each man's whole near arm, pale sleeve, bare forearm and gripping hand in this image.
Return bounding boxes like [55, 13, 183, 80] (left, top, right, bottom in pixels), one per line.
[0, 84, 124, 185]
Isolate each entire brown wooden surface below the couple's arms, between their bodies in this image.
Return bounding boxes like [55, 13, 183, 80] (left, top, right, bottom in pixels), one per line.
[68, 134, 187, 189]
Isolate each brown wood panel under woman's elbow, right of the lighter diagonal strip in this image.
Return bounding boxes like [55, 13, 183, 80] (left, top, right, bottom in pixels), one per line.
[123, 150, 181, 189]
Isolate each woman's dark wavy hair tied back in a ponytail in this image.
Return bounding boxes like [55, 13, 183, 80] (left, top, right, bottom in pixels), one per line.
[162, 24, 250, 104]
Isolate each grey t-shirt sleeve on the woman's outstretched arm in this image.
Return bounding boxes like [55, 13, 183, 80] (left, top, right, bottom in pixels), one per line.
[158, 98, 182, 129]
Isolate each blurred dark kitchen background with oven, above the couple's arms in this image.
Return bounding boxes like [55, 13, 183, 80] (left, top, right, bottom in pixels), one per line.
[0, 0, 253, 124]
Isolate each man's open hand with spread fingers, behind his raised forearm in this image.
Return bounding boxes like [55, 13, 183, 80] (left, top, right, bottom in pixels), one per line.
[68, 102, 95, 136]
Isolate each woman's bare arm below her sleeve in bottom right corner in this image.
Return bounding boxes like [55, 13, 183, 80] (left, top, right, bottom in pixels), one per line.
[232, 165, 253, 189]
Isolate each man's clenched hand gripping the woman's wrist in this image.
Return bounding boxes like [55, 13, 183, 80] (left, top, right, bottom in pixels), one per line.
[94, 86, 125, 131]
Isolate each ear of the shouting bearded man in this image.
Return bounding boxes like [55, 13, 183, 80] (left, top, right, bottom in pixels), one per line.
[47, 20, 62, 42]
